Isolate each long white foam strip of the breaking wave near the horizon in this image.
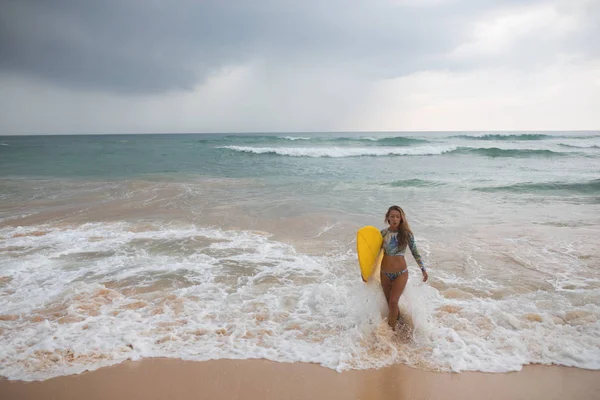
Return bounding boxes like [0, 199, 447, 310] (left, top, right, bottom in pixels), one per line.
[219, 144, 458, 158]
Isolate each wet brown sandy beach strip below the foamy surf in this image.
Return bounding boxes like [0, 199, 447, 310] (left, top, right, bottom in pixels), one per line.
[0, 358, 600, 400]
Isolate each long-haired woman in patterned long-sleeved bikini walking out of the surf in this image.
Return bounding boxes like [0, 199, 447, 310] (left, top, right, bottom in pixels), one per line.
[381, 206, 429, 328]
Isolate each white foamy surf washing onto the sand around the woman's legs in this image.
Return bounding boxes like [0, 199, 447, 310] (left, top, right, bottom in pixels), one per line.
[0, 223, 600, 380]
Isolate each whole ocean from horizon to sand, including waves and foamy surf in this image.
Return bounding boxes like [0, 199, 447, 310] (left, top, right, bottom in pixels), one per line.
[0, 132, 600, 380]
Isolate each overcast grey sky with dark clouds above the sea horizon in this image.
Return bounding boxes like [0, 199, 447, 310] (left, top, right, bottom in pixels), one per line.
[0, 0, 600, 134]
